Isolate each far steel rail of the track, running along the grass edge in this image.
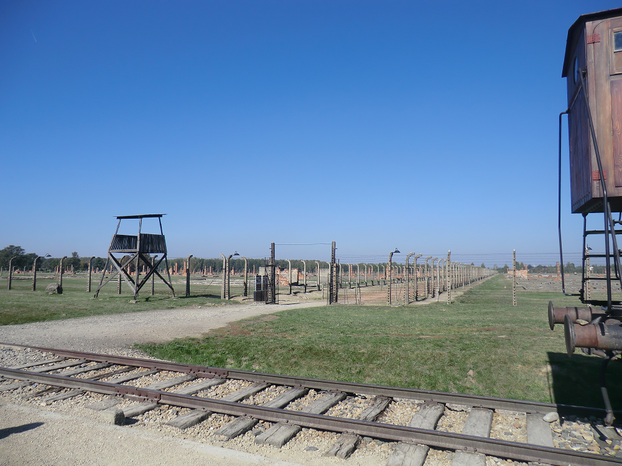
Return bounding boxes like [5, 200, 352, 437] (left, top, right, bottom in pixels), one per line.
[0, 343, 619, 416]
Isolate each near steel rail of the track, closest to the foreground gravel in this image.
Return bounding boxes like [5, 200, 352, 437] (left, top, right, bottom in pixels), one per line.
[0, 368, 622, 466]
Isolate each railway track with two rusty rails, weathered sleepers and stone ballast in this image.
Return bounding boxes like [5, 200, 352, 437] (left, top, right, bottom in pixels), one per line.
[0, 345, 622, 466]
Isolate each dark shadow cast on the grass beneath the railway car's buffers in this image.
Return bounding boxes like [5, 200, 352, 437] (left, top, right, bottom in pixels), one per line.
[548, 352, 622, 417]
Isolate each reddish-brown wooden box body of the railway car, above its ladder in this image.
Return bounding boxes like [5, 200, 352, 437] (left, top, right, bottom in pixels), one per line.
[562, 8, 622, 214]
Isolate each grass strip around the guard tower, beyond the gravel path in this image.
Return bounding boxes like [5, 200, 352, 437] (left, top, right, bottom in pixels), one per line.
[0, 272, 236, 325]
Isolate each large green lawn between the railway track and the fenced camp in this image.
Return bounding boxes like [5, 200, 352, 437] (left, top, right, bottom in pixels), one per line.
[140, 275, 622, 409]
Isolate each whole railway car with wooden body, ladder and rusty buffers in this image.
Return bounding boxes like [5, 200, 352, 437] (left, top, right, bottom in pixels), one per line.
[548, 8, 622, 424]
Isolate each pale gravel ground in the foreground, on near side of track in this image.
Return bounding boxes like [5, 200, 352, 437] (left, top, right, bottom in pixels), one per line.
[0, 403, 299, 466]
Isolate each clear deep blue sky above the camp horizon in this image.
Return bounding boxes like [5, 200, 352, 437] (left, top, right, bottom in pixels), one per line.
[0, 0, 620, 266]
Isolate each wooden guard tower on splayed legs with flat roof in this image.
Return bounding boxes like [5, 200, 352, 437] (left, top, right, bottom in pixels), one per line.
[95, 214, 175, 299]
